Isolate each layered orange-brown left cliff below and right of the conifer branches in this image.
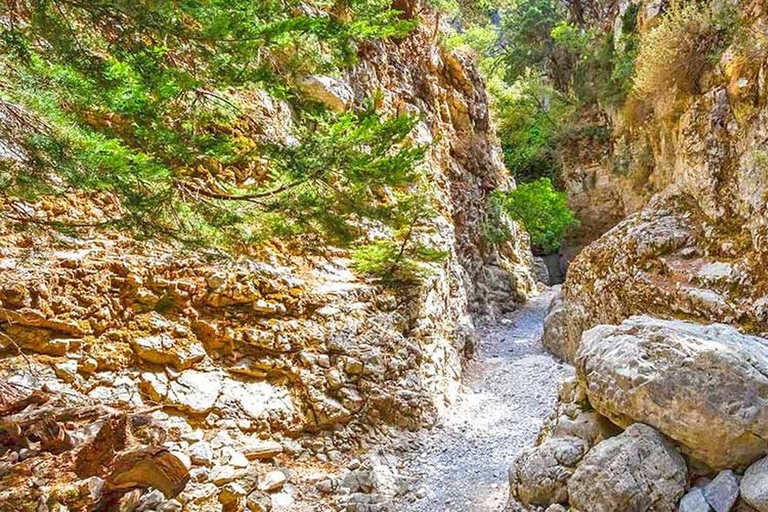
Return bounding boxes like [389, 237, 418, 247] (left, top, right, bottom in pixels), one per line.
[0, 9, 535, 510]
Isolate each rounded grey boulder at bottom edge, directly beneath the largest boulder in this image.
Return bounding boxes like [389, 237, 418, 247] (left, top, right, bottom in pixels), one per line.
[568, 423, 687, 512]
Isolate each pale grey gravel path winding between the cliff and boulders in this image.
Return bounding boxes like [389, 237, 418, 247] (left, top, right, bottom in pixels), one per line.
[397, 290, 573, 512]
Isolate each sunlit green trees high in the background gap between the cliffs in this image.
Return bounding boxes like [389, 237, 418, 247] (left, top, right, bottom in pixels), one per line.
[449, 0, 638, 182]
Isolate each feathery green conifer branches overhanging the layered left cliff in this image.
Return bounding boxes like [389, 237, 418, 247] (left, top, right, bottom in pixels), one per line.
[0, 0, 438, 274]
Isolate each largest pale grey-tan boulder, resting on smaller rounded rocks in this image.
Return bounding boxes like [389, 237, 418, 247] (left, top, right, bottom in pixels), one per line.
[576, 316, 768, 469]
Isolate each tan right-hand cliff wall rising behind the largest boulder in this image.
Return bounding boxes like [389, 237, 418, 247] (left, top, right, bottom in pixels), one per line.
[548, 2, 768, 353]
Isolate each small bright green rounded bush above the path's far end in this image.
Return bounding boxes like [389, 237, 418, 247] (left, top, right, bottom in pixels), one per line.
[498, 178, 577, 252]
